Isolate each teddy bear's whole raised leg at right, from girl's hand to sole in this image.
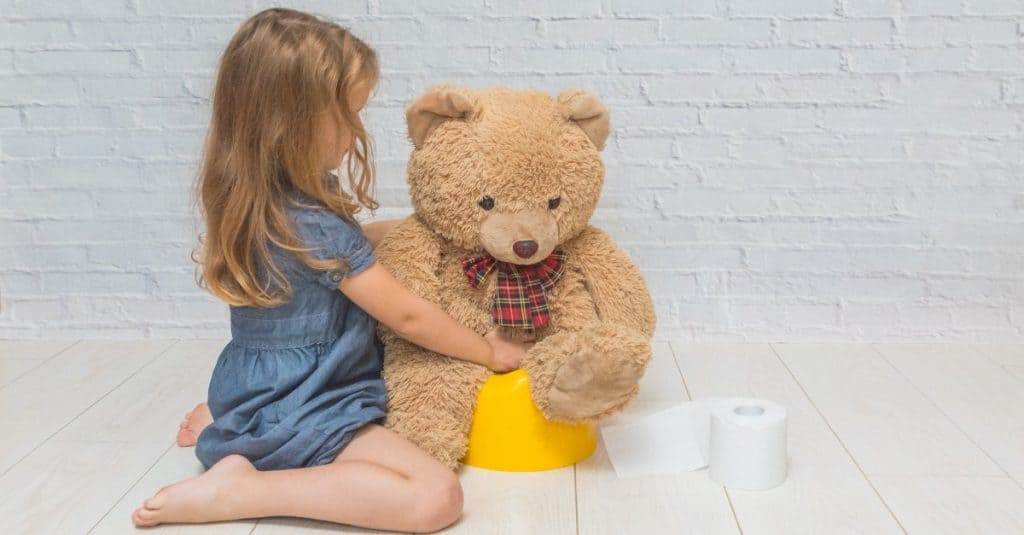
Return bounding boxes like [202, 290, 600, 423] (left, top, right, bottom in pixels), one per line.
[523, 323, 651, 422]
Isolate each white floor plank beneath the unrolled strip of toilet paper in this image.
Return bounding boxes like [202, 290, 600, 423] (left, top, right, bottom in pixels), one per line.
[577, 342, 738, 535]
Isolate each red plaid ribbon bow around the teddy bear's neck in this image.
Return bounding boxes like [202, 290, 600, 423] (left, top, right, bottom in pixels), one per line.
[462, 249, 565, 330]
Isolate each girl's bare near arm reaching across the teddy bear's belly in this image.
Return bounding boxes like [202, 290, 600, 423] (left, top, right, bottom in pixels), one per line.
[338, 262, 531, 372]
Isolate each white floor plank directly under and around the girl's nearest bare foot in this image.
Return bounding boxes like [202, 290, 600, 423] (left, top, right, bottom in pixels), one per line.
[90, 442, 256, 535]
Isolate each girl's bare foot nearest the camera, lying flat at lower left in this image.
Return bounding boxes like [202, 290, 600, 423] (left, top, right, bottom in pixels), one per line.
[131, 455, 256, 527]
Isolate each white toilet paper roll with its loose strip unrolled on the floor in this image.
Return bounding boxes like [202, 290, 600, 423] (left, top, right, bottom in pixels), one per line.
[601, 398, 786, 490]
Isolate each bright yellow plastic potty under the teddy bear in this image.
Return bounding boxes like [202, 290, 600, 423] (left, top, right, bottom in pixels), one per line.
[462, 370, 597, 471]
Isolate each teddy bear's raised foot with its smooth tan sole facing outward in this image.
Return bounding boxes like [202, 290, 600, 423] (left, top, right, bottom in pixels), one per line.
[546, 324, 650, 421]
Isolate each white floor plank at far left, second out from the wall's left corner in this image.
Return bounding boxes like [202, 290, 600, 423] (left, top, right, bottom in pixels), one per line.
[0, 340, 174, 474]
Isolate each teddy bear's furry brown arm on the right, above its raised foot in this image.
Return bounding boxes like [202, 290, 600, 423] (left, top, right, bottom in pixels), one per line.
[567, 227, 655, 336]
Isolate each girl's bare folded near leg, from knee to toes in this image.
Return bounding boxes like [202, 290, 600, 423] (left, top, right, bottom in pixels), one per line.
[132, 425, 462, 532]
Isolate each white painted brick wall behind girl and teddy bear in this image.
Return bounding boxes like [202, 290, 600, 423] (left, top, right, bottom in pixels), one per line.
[0, 0, 1024, 341]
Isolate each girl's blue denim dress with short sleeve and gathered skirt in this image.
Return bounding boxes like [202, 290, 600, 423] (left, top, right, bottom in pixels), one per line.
[196, 189, 387, 470]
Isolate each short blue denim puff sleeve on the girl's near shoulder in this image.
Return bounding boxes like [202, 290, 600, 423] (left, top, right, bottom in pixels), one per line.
[297, 210, 376, 290]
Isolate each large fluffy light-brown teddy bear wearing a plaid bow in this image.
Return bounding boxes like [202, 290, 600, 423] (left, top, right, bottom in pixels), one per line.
[377, 85, 655, 469]
